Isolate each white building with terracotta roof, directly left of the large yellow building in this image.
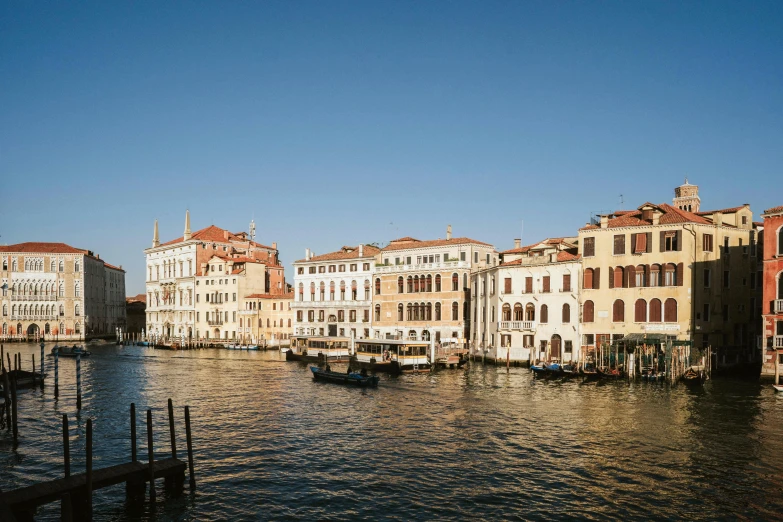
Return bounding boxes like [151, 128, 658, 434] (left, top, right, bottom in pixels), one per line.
[471, 238, 581, 362]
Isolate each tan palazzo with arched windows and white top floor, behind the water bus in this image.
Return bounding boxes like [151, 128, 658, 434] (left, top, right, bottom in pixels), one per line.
[372, 230, 497, 341]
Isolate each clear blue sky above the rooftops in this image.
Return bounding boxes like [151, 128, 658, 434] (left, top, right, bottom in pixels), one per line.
[0, 0, 783, 295]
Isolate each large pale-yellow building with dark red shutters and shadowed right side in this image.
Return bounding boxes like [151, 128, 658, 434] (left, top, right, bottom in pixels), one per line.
[579, 185, 756, 357]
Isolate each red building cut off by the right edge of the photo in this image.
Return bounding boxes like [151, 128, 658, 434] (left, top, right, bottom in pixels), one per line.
[761, 206, 783, 375]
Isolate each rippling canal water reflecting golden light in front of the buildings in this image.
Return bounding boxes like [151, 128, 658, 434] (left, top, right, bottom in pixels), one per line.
[0, 344, 783, 521]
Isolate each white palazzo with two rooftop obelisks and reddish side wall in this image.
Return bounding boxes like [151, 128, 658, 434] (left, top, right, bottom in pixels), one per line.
[144, 212, 285, 340]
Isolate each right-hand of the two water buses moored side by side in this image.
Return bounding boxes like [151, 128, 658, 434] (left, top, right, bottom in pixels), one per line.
[350, 339, 432, 373]
